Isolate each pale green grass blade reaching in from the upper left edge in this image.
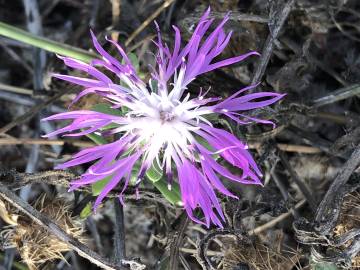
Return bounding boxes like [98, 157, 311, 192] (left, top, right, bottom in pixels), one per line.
[0, 22, 99, 63]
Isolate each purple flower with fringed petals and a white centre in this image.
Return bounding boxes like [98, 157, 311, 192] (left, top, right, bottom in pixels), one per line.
[44, 9, 283, 227]
